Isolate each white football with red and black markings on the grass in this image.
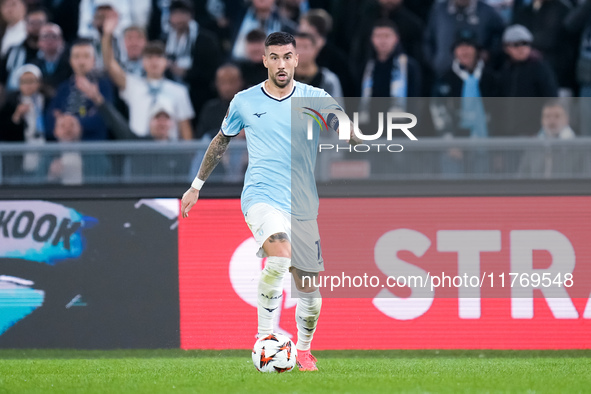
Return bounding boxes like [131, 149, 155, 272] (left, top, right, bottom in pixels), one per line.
[252, 334, 297, 373]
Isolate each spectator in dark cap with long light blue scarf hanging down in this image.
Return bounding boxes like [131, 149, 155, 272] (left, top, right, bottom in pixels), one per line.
[431, 30, 497, 176]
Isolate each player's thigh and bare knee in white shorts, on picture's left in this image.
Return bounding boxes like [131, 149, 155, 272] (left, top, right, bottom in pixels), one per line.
[245, 203, 291, 258]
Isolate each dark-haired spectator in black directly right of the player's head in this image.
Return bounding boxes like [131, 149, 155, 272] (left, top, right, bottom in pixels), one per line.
[298, 8, 352, 97]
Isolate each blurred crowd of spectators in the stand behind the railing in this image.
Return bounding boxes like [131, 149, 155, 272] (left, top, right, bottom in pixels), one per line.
[0, 0, 591, 182]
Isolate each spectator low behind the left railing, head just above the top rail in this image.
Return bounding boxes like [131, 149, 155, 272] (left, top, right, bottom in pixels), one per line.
[41, 114, 111, 185]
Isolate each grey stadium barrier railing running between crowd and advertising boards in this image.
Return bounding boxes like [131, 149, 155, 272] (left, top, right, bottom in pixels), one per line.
[0, 137, 591, 186]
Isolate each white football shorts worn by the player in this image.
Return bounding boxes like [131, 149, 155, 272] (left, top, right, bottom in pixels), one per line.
[244, 203, 324, 272]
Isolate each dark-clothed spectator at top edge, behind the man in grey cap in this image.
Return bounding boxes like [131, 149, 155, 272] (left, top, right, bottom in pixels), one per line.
[513, 0, 577, 96]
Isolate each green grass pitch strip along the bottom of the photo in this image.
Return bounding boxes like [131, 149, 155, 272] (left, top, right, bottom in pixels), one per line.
[0, 350, 591, 394]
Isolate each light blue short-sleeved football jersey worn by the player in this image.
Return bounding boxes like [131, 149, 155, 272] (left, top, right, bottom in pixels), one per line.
[221, 81, 340, 220]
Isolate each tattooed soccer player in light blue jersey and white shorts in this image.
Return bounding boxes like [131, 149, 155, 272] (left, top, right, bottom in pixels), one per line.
[181, 32, 356, 371]
